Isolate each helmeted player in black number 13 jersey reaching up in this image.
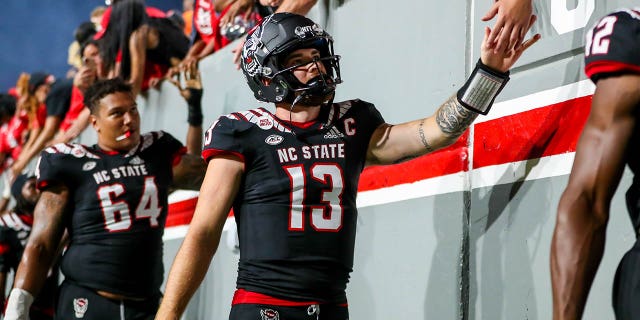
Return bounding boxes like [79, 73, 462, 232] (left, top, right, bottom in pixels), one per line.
[156, 13, 539, 320]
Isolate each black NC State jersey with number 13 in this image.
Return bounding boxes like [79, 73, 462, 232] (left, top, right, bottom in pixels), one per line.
[202, 100, 384, 303]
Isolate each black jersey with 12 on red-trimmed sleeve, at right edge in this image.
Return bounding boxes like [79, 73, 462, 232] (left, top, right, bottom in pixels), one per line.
[585, 8, 640, 234]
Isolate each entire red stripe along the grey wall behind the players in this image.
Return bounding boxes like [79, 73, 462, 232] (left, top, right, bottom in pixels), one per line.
[166, 96, 591, 227]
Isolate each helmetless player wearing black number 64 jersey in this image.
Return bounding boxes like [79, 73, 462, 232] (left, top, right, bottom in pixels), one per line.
[5, 64, 205, 320]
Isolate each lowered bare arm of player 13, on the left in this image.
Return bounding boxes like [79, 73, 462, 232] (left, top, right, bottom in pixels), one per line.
[156, 156, 244, 320]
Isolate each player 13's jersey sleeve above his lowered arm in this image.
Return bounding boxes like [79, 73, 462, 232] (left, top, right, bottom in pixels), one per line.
[202, 116, 249, 162]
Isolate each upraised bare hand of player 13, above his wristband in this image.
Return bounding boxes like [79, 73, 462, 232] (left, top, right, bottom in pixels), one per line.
[480, 15, 540, 72]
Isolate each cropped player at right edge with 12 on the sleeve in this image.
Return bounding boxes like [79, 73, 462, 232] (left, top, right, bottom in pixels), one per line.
[551, 8, 640, 320]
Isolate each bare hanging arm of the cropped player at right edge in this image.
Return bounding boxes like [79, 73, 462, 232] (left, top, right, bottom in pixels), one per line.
[551, 75, 640, 320]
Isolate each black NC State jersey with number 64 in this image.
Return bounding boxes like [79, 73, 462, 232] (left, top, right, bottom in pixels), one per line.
[36, 131, 183, 297]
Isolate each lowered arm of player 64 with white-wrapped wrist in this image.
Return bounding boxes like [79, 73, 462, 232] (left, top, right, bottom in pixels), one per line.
[5, 184, 69, 320]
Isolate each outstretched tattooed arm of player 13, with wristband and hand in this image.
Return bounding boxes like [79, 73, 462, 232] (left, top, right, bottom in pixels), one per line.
[367, 21, 540, 164]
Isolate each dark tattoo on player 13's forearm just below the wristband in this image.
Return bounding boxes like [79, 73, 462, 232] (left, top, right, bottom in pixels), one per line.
[436, 95, 478, 137]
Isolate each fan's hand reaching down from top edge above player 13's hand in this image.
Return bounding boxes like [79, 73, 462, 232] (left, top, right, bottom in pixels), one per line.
[482, 0, 533, 52]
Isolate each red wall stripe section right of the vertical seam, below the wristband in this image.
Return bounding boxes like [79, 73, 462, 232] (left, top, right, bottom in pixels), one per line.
[473, 96, 591, 169]
